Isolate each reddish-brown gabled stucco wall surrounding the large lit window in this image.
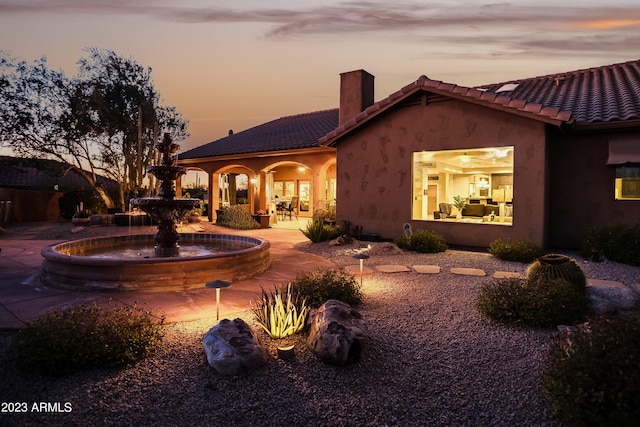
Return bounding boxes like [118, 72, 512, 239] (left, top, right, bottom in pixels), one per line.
[336, 96, 547, 247]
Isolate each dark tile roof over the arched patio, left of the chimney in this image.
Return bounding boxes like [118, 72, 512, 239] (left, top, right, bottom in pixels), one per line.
[179, 108, 338, 160]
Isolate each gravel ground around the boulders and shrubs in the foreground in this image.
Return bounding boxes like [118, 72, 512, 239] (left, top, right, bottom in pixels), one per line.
[0, 226, 639, 426]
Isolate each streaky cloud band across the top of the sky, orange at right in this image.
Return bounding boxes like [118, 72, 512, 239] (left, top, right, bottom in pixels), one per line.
[0, 0, 640, 54]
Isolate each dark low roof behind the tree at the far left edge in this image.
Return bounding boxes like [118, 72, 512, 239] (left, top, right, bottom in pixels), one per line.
[0, 156, 117, 192]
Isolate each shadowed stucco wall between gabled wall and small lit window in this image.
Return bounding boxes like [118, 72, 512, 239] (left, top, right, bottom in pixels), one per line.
[549, 133, 640, 248]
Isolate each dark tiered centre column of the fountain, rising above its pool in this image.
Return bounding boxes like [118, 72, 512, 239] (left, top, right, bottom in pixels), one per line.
[131, 133, 200, 257]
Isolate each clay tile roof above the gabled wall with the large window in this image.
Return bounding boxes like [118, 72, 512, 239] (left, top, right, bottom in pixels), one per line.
[319, 60, 640, 146]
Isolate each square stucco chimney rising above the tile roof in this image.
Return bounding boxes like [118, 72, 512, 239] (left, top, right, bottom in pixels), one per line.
[338, 70, 375, 125]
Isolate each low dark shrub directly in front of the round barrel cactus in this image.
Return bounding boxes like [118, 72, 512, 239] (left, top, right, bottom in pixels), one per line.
[476, 278, 591, 327]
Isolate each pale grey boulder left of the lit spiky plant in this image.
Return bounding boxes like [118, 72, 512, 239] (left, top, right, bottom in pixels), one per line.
[202, 319, 268, 375]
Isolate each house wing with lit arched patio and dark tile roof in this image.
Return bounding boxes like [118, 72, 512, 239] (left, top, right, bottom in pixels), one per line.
[178, 108, 338, 222]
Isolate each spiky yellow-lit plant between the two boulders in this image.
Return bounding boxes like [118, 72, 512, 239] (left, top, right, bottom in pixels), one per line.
[251, 283, 309, 338]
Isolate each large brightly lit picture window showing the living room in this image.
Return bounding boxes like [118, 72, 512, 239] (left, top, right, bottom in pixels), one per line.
[412, 146, 514, 225]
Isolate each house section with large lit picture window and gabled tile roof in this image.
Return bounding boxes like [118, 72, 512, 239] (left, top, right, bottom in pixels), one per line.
[319, 61, 640, 247]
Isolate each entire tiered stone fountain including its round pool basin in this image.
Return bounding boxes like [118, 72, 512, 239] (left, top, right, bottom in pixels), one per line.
[40, 134, 271, 291]
